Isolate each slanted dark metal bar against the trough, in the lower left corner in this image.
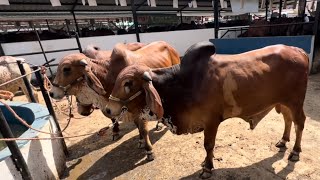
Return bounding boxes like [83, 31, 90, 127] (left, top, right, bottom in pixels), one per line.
[0, 109, 32, 180]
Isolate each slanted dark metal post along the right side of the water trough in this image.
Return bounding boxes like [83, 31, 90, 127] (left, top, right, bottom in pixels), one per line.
[32, 66, 68, 155]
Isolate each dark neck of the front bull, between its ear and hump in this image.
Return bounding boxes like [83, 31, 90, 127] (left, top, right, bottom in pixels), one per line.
[152, 65, 202, 133]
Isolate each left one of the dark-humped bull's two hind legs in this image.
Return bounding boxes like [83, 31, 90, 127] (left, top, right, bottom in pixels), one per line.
[276, 105, 293, 151]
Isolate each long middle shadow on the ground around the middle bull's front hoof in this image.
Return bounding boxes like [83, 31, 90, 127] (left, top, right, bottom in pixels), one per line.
[78, 129, 167, 179]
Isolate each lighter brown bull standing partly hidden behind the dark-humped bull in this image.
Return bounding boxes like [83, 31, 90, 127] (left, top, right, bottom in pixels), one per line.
[51, 41, 180, 160]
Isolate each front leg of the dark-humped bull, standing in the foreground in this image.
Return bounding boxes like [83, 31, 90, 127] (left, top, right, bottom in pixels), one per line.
[200, 125, 219, 179]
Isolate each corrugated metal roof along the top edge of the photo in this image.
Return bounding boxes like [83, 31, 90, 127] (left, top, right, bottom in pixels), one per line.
[0, 0, 302, 20]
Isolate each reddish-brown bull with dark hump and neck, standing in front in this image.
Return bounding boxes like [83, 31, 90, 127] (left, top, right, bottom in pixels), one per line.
[106, 42, 308, 178]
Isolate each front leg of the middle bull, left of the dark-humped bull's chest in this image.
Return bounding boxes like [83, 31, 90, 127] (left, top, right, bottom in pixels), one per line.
[139, 119, 154, 161]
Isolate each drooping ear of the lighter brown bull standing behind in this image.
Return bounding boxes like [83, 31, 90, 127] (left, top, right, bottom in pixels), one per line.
[80, 59, 106, 95]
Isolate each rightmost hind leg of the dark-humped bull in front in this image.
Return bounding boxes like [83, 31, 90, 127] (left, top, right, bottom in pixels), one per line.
[288, 107, 306, 161]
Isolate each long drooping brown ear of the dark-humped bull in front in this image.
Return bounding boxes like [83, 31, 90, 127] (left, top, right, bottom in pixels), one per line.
[143, 73, 163, 119]
